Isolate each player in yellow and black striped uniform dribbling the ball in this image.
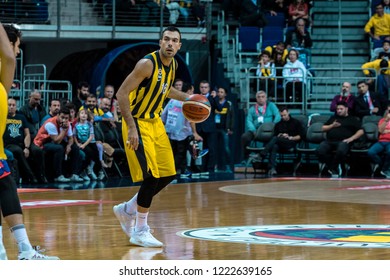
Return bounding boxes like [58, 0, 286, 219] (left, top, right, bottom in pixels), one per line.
[113, 26, 189, 247]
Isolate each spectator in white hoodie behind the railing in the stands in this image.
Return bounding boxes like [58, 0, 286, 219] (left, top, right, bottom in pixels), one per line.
[283, 49, 306, 103]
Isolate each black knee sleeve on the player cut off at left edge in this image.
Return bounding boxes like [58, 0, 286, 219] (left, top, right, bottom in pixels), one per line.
[0, 175, 22, 217]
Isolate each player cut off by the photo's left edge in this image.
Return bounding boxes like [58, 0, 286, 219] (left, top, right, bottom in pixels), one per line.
[0, 24, 59, 260]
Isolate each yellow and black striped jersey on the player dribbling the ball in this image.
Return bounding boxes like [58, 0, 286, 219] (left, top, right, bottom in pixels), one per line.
[129, 51, 177, 119]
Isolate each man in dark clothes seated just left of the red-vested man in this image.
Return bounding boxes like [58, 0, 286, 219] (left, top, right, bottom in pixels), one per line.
[19, 90, 47, 139]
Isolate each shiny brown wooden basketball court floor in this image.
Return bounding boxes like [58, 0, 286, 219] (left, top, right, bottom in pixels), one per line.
[3, 175, 390, 260]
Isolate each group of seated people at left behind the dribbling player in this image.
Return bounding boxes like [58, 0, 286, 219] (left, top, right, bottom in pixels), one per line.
[3, 82, 126, 184]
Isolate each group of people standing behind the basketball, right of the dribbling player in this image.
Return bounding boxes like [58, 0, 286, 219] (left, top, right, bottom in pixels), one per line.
[162, 79, 235, 178]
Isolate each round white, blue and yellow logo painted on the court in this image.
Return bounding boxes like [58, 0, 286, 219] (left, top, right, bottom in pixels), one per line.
[177, 225, 390, 248]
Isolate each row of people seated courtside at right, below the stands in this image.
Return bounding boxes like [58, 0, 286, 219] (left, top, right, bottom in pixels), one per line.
[241, 80, 390, 178]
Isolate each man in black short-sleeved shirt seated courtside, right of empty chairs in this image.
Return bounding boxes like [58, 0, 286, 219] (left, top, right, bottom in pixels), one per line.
[317, 101, 364, 176]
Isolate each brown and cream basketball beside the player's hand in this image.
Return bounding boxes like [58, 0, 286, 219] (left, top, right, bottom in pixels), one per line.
[183, 94, 211, 123]
